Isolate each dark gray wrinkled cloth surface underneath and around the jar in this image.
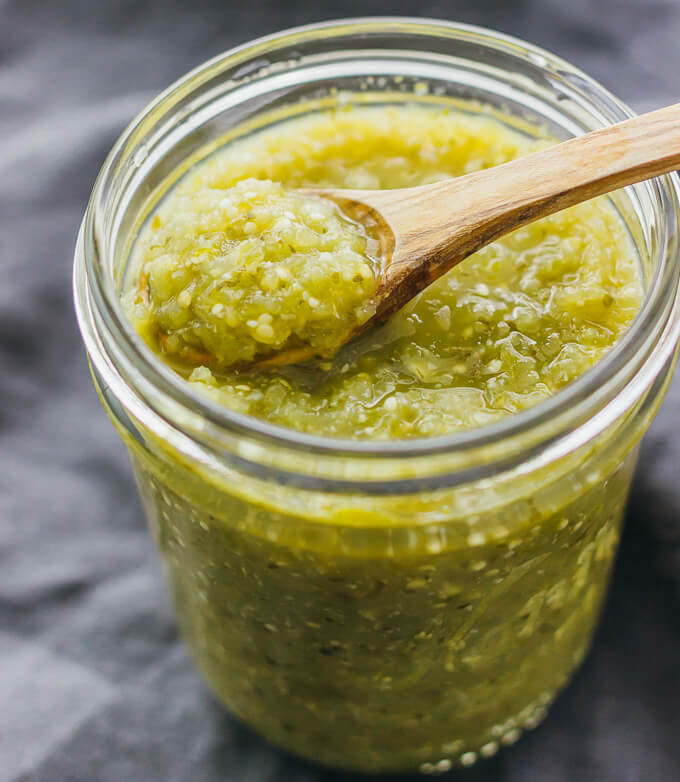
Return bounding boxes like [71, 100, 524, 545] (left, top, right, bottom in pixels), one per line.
[0, 0, 680, 782]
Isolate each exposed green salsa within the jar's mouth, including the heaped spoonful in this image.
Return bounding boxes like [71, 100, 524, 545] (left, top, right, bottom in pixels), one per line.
[126, 106, 642, 439]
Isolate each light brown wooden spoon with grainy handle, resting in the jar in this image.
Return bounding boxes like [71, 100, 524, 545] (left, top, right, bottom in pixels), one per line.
[255, 103, 680, 368]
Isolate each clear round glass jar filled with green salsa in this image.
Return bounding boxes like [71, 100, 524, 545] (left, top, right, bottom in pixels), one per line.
[75, 19, 680, 772]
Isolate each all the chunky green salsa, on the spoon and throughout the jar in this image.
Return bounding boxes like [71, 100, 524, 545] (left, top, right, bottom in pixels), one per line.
[123, 101, 642, 773]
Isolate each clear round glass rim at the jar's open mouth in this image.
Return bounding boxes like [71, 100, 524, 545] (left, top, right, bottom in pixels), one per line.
[74, 16, 680, 483]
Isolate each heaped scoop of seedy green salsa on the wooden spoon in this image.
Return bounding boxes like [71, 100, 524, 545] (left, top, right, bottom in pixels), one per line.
[129, 179, 377, 369]
